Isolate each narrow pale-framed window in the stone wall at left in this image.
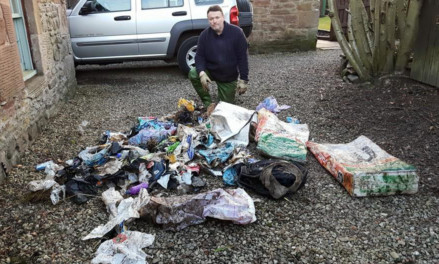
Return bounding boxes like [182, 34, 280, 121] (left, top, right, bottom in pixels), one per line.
[9, 0, 35, 76]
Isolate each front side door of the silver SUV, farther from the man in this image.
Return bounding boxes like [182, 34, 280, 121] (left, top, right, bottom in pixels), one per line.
[68, 0, 139, 61]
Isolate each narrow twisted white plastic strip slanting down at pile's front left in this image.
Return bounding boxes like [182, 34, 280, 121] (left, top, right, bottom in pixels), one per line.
[82, 189, 150, 240]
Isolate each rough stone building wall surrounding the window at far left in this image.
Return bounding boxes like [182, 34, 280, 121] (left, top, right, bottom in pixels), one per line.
[0, 0, 76, 180]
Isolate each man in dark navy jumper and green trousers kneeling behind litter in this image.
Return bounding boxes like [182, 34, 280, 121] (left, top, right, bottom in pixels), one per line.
[189, 5, 248, 107]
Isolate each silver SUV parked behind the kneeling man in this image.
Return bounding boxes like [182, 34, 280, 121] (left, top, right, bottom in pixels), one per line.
[67, 0, 253, 74]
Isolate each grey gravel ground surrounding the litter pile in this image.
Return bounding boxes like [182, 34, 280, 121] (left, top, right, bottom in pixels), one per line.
[0, 51, 439, 263]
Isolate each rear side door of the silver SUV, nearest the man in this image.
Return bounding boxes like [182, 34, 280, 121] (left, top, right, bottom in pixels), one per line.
[137, 0, 192, 57]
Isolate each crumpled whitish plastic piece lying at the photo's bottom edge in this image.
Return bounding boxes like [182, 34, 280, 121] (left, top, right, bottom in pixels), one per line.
[91, 231, 155, 264]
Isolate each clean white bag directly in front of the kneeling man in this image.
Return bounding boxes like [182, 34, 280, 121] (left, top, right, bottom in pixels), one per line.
[210, 102, 256, 146]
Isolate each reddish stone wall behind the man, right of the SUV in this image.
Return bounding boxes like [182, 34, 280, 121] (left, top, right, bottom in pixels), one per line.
[249, 0, 320, 53]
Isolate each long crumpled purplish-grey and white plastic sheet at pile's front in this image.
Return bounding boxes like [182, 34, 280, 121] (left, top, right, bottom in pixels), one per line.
[140, 188, 256, 231]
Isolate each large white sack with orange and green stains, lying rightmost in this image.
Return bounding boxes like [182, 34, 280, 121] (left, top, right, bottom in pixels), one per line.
[307, 136, 419, 197]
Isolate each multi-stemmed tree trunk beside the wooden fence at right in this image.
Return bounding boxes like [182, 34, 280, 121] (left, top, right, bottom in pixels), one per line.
[328, 0, 424, 81]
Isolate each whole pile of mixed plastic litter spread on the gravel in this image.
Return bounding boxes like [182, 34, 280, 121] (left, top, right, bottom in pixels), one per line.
[28, 97, 418, 263]
